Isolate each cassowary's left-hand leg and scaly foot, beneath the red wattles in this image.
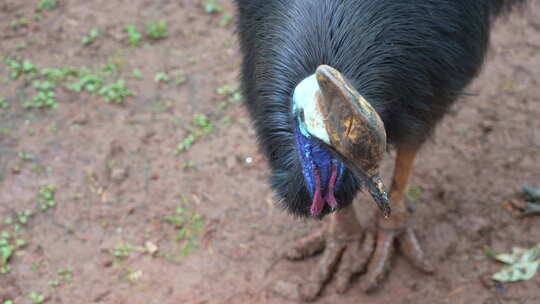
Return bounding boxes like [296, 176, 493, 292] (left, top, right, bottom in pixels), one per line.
[280, 205, 374, 301]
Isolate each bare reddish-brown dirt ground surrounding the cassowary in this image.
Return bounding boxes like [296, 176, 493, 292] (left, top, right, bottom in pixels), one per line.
[0, 0, 540, 304]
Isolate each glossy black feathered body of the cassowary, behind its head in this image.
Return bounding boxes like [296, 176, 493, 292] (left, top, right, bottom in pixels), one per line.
[236, 0, 521, 215]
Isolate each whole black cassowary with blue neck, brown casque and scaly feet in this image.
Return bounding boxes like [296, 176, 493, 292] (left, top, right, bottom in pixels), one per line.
[235, 0, 524, 300]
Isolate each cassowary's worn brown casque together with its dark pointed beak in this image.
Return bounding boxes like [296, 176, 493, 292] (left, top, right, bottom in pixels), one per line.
[316, 65, 390, 217]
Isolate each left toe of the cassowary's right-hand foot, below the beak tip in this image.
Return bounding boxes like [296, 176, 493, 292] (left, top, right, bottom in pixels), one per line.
[363, 230, 397, 293]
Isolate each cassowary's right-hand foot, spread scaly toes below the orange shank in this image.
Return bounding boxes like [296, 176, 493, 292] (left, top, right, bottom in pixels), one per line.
[362, 220, 433, 293]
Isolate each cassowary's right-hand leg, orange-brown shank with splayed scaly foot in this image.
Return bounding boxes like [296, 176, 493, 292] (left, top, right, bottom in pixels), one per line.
[364, 147, 433, 292]
